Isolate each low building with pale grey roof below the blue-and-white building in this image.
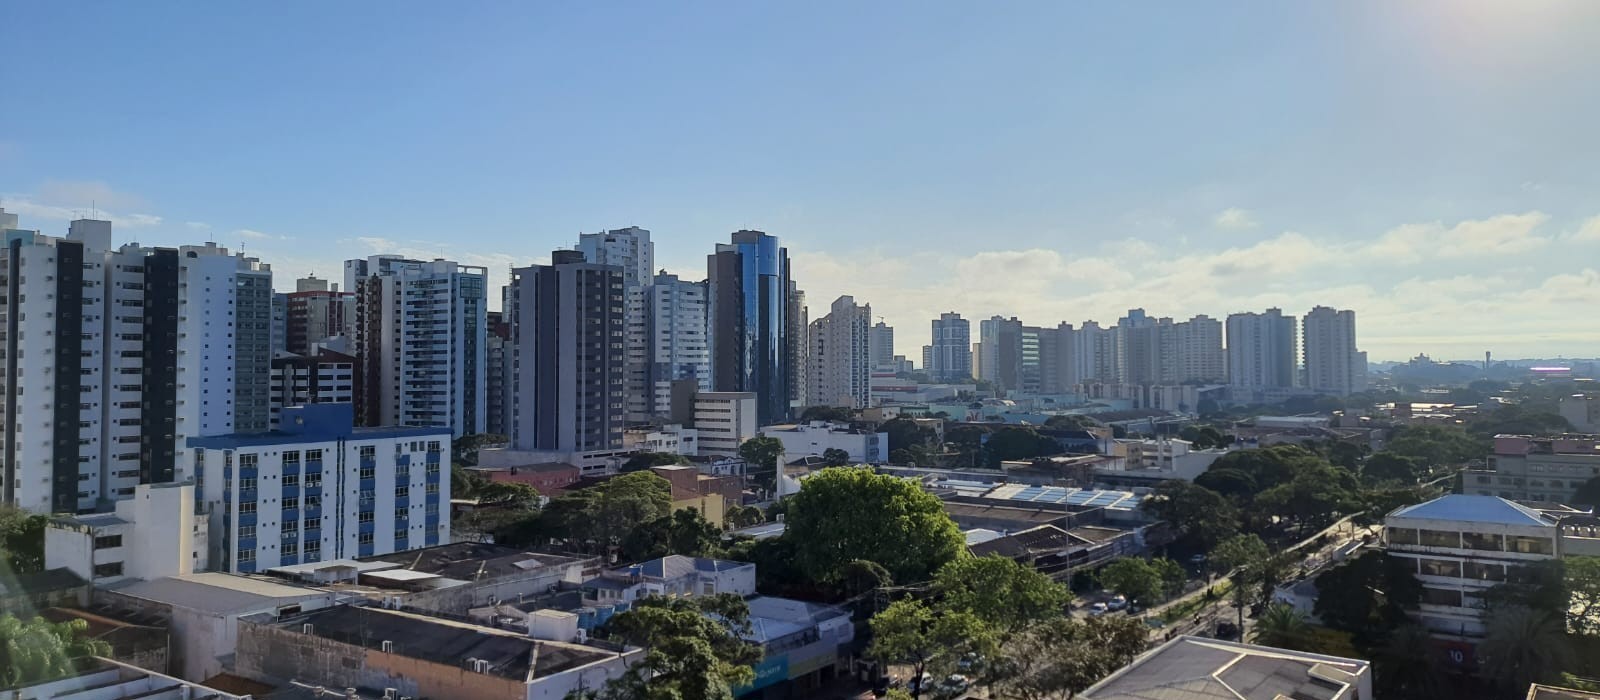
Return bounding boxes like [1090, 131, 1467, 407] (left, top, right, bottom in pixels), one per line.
[94, 574, 341, 682]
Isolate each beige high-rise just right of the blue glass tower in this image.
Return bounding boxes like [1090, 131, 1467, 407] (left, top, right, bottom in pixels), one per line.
[808, 296, 874, 408]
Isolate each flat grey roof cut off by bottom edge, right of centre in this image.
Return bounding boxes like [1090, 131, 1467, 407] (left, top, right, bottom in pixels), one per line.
[1078, 634, 1368, 700]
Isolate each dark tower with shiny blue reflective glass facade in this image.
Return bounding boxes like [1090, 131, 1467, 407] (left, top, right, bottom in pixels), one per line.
[706, 230, 797, 425]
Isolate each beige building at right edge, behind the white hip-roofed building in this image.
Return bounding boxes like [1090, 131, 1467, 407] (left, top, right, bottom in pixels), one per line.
[1461, 435, 1600, 503]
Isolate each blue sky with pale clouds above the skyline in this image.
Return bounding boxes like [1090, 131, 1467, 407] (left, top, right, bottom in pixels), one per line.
[0, 2, 1600, 360]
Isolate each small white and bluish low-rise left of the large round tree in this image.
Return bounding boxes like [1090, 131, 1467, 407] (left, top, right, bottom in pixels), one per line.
[584, 555, 755, 604]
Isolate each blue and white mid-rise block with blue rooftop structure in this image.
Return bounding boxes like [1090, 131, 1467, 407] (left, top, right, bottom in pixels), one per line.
[184, 404, 451, 574]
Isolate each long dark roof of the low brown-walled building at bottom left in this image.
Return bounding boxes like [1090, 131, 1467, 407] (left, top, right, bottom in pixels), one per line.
[277, 606, 614, 681]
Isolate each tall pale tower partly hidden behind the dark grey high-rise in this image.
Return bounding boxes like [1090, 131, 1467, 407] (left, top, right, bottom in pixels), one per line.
[578, 227, 656, 422]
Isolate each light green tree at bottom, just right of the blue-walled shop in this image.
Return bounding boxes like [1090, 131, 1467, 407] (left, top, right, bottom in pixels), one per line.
[867, 599, 997, 698]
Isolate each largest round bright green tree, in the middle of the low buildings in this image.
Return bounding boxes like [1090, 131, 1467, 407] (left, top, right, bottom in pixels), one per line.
[784, 467, 966, 582]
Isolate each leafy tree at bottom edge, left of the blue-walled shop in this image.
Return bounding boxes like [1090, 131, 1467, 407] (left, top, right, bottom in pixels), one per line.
[597, 593, 762, 700]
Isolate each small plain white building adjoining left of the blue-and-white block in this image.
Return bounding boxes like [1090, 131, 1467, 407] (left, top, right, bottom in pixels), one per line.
[45, 483, 210, 587]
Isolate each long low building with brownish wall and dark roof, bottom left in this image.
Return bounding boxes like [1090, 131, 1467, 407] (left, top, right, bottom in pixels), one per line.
[235, 606, 643, 700]
